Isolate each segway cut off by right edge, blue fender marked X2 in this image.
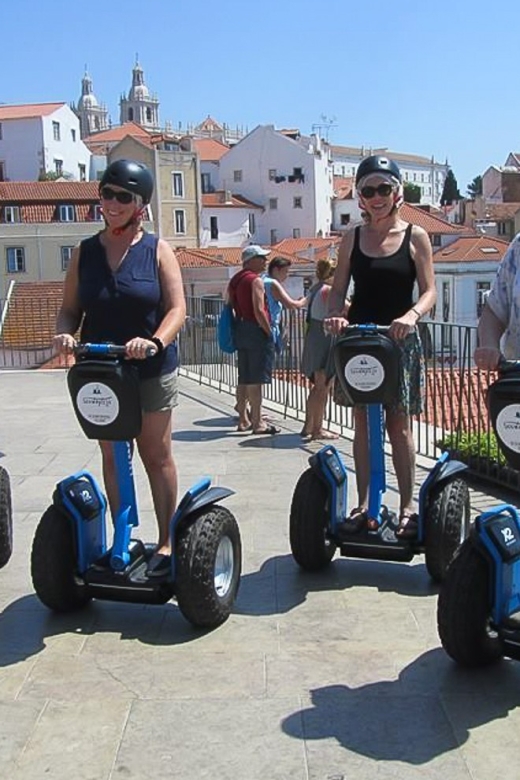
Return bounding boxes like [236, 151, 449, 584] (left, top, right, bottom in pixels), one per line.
[437, 360, 520, 667]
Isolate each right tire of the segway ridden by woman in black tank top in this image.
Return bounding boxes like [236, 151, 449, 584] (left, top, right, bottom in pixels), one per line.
[424, 478, 471, 582]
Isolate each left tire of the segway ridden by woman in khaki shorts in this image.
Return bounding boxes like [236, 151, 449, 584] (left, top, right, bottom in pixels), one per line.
[31, 505, 91, 612]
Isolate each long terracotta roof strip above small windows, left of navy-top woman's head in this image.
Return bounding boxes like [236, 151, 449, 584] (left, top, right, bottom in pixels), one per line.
[0, 181, 99, 205]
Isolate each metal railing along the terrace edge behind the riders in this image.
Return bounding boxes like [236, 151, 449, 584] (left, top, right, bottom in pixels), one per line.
[0, 298, 520, 487]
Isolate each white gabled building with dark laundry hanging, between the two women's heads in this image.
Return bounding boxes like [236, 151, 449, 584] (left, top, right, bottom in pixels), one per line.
[219, 125, 332, 244]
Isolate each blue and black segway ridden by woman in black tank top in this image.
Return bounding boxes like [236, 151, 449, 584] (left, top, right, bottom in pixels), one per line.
[290, 325, 470, 582]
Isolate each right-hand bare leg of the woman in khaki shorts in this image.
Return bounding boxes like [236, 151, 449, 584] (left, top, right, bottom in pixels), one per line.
[137, 410, 177, 555]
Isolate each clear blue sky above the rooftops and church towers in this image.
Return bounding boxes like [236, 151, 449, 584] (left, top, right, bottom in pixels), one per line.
[0, 0, 520, 192]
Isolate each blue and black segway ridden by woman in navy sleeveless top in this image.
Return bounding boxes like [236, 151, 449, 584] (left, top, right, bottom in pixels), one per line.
[31, 344, 241, 628]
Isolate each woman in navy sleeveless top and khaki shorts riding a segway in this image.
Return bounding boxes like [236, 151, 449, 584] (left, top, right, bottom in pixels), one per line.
[54, 160, 186, 575]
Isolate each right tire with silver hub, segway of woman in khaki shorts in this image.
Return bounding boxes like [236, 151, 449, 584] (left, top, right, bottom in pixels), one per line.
[175, 505, 242, 628]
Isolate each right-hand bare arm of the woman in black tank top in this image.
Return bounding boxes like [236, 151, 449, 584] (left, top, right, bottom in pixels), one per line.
[389, 226, 437, 339]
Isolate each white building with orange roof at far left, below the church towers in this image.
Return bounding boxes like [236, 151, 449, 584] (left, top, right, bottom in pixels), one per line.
[0, 103, 90, 181]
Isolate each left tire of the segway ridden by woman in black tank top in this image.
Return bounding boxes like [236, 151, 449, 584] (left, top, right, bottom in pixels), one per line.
[289, 469, 336, 571]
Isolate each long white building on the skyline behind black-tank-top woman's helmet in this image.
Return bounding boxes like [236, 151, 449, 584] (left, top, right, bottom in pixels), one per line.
[330, 145, 449, 206]
